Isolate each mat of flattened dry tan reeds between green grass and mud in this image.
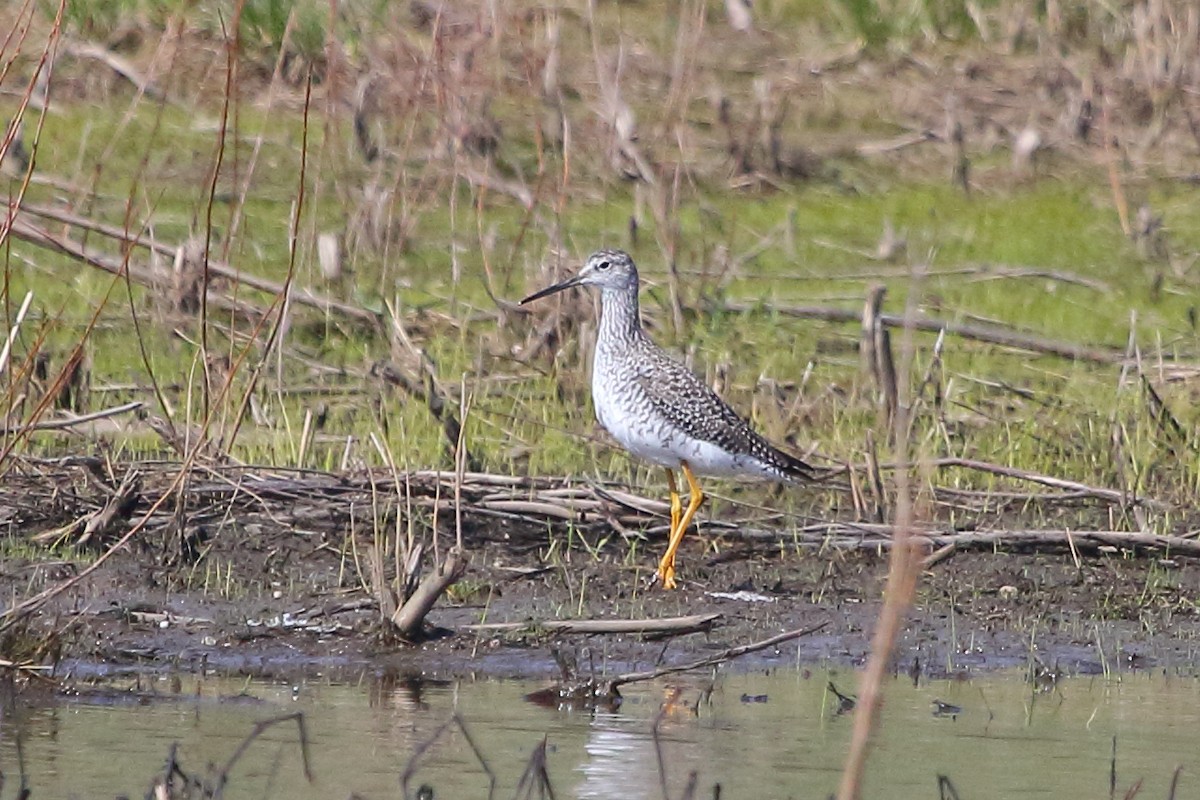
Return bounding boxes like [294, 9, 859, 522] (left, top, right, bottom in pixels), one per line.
[0, 457, 1200, 559]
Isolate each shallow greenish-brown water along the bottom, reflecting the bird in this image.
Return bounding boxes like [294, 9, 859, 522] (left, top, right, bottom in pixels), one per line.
[0, 672, 1200, 800]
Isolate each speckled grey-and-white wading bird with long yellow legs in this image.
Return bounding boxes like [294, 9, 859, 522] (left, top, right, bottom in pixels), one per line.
[521, 249, 812, 589]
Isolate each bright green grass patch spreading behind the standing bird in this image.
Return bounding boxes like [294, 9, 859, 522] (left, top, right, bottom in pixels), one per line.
[0, 2, 1200, 546]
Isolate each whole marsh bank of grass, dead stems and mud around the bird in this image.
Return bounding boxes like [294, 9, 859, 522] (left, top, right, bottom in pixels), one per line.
[0, 0, 1200, 796]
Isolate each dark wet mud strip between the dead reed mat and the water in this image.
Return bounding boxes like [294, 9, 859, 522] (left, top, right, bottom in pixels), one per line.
[2, 506, 1200, 679]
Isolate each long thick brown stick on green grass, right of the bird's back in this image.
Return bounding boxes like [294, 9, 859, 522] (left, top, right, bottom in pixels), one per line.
[721, 302, 1124, 363]
